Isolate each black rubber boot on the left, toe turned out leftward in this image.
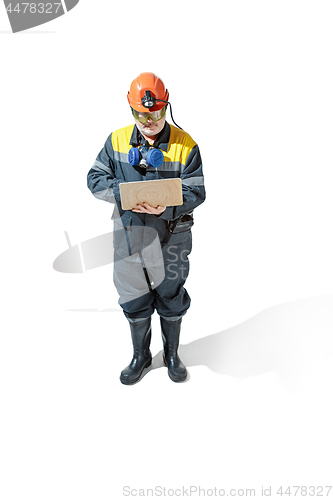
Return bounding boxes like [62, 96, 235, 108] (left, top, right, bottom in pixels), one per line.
[120, 318, 152, 385]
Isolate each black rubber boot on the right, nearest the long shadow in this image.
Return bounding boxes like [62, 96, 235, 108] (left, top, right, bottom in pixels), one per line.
[161, 317, 187, 382]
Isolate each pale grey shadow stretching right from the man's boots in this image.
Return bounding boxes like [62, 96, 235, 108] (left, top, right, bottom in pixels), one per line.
[68, 295, 333, 390]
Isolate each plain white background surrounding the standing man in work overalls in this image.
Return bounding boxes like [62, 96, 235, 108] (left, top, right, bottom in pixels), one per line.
[0, 0, 333, 500]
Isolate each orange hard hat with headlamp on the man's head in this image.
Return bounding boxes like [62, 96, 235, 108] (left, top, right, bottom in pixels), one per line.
[127, 73, 169, 112]
